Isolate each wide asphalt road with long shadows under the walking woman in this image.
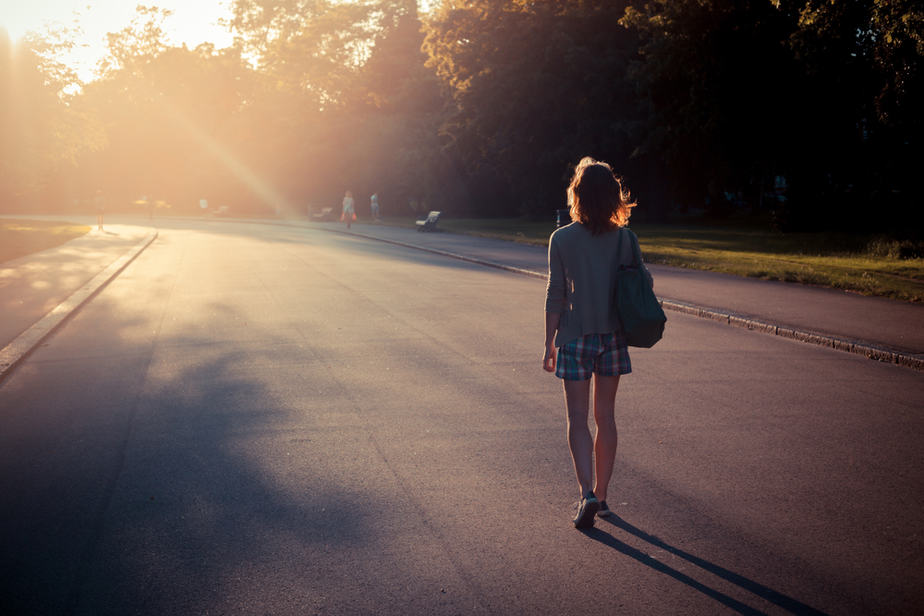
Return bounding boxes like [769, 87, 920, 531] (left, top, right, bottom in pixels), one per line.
[0, 222, 924, 614]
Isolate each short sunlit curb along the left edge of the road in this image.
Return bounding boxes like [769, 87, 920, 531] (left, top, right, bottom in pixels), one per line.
[0, 229, 158, 381]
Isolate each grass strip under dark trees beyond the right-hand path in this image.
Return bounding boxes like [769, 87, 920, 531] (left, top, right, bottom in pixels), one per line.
[382, 217, 924, 302]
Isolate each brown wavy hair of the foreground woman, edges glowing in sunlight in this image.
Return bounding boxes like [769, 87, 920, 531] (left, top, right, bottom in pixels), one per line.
[568, 156, 636, 235]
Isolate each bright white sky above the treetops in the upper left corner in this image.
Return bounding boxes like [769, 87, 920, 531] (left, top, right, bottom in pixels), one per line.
[0, 0, 232, 82]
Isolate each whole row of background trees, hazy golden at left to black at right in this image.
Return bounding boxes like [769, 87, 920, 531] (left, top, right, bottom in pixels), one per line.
[0, 0, 924, 234]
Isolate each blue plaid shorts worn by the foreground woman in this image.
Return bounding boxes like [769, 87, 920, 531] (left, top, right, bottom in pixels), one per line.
[555, 334, 632, 381]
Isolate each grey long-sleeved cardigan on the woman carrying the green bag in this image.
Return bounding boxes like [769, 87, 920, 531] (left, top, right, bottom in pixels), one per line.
[545, 222, 652, 347]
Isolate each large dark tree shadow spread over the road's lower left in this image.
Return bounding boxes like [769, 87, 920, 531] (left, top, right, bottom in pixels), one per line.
[0, 258, 426, 614]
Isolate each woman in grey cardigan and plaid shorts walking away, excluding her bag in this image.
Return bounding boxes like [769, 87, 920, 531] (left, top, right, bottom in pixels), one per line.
[542, 157, 651, 528]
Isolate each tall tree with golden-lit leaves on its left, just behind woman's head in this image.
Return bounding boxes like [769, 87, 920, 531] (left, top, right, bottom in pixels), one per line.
[424, 0, 633, 217]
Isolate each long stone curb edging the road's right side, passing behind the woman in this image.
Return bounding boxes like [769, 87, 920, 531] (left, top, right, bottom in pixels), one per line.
[336, 229, 924, 371]
